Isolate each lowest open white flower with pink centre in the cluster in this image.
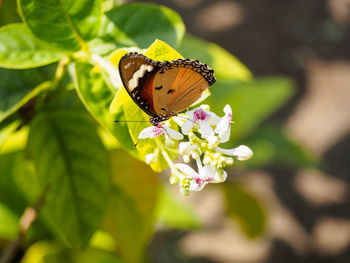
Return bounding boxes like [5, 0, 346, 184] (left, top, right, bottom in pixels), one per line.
[176, 159, 227, 191]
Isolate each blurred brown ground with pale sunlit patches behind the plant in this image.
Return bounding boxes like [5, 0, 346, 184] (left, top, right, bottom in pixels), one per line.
[128, 0, 350, 263]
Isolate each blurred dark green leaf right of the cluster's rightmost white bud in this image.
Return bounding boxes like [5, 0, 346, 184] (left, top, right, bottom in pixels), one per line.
[240, 125, 320, 168]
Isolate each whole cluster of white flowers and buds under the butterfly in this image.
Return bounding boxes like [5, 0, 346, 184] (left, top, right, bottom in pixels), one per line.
[139, 105, 253, 195]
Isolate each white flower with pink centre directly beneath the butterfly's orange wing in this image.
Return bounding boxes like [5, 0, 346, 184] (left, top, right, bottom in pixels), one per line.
[181, 105, 220, 139]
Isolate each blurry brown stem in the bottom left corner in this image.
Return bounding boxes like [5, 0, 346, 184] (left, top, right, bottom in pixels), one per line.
[0, 194, 46, 263]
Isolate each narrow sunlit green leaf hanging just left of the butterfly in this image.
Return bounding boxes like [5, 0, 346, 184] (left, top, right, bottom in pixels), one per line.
[74, 63, 138, 157]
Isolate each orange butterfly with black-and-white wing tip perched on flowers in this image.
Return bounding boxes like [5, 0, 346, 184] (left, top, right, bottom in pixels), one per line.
[119, 52, 216, 125]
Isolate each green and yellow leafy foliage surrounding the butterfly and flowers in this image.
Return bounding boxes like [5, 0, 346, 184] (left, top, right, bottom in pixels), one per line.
[0, 0, 317, 263]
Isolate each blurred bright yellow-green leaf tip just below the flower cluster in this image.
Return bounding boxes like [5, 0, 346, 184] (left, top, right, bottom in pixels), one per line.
[156, 186, 200, 230]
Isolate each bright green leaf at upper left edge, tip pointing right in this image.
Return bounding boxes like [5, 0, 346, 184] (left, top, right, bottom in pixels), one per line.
[0, 24, 65, 69]
